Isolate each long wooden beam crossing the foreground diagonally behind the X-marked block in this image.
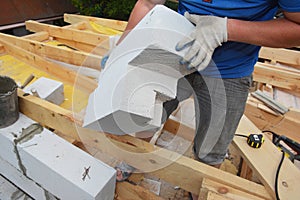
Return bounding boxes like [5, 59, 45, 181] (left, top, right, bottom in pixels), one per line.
[21, 92, 270, 199]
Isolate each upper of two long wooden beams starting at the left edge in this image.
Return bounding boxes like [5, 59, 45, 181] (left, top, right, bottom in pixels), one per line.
[0, 33, 102, 70]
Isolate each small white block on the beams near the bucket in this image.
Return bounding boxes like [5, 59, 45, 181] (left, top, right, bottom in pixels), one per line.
[24, 77, 65, 105]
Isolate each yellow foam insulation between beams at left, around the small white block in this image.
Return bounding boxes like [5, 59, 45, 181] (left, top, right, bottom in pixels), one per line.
[0, 54, 89, 113]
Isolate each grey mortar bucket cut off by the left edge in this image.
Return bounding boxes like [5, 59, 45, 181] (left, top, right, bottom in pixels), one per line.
[0, 76, 19, 128]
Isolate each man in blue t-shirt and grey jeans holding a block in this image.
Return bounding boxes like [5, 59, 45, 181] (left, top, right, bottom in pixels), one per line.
[105, 0, 300, 199]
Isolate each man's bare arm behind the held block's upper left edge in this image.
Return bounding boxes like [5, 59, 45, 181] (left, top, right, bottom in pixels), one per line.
[118, 0, 166, 43]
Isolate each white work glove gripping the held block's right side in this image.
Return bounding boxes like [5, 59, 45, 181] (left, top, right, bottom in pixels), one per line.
[176, 12, 227, 71]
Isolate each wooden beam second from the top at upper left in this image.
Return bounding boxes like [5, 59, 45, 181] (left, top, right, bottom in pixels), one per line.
[25, 20, 110, 49]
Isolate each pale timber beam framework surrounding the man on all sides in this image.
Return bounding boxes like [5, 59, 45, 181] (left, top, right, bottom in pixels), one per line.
[0, 14, 300, 200]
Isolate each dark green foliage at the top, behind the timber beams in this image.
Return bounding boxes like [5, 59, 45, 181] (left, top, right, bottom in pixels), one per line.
[72, 0, 177, 21]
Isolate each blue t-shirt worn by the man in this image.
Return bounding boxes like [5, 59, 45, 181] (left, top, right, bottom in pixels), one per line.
[178, 0, 300, 78]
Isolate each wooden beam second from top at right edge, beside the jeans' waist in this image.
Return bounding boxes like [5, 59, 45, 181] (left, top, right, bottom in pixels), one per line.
[253, 63, 300, 93]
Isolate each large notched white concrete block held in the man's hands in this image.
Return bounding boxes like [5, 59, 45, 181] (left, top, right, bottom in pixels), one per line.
[84, 5, 194, 135]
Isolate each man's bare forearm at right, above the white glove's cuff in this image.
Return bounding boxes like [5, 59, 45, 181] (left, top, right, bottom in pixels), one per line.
[227, 12, 300, 48]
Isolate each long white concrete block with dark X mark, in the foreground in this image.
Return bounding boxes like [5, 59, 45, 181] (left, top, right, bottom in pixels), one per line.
[0, 114, 116, 200]
